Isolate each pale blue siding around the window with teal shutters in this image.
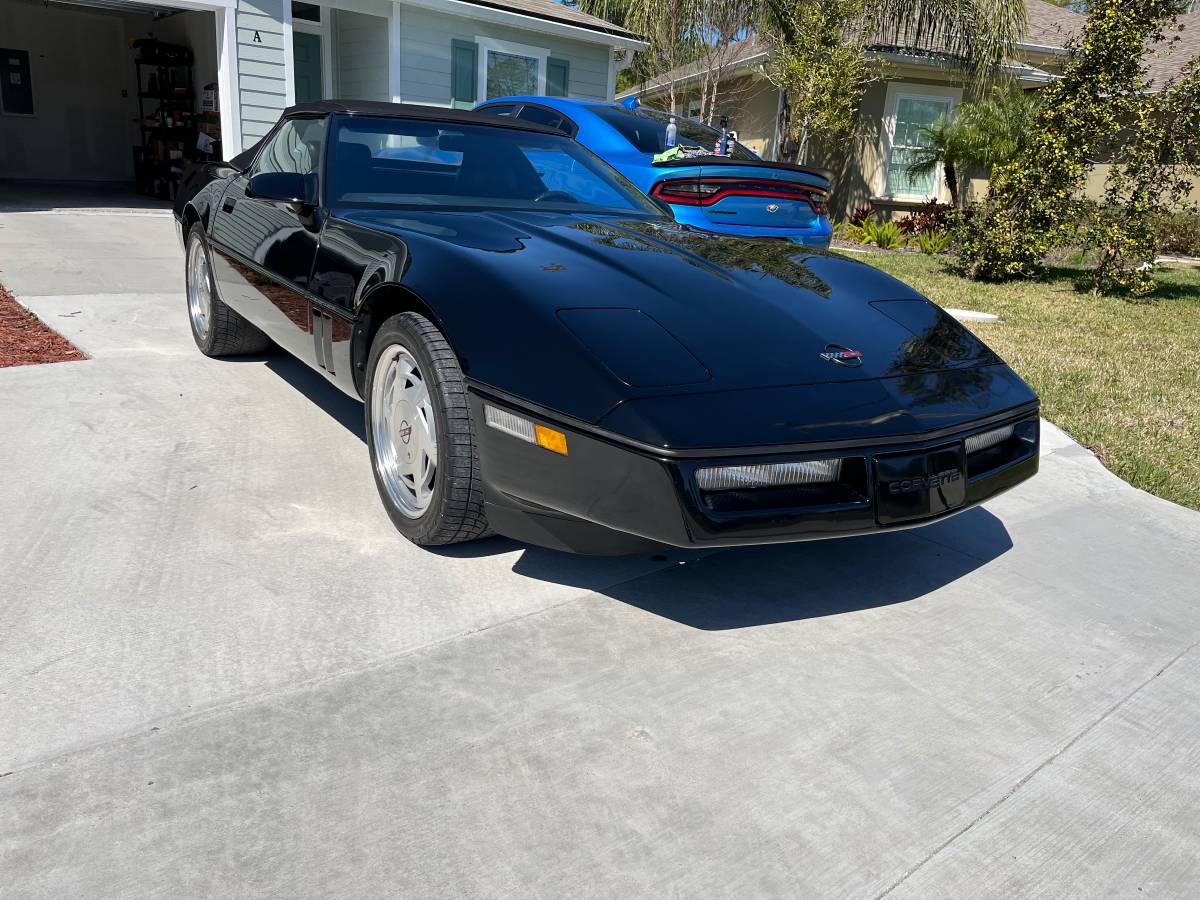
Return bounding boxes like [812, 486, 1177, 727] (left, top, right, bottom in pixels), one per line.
[400, 6, 611, 106]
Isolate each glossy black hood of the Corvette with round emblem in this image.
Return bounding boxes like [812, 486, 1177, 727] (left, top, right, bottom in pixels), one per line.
[341, 212, 998, 421]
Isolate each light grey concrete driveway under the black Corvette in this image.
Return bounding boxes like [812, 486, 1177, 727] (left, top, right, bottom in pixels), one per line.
[0, 196, 1200, 898]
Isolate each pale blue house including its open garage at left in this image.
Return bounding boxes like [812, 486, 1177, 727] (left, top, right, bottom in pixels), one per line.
[0, 0, 646, 182]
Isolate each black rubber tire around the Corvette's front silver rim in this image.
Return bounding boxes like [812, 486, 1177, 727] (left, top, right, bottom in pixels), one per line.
[364, 312, 490, 547]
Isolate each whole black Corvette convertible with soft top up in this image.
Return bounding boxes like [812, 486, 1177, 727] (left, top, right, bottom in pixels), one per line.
[175, 102, 1038, 553]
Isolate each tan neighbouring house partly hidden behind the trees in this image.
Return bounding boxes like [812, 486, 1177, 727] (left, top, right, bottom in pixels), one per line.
[620, 0, 1084, 217]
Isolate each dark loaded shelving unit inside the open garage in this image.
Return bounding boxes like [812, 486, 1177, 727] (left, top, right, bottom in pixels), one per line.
[133, 42, 197, 200]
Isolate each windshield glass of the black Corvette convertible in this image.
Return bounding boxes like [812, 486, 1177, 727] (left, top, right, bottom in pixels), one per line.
[329, 116, 659, 214]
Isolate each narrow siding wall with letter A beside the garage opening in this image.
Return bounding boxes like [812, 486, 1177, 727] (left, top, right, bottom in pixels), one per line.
[238, 0, 289, 146]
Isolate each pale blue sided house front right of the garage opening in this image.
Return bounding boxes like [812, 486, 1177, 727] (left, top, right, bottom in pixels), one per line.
[246, 0, 646, 153]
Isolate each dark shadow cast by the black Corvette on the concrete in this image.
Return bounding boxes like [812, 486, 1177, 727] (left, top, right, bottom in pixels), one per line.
[262, 353, 1013, 631]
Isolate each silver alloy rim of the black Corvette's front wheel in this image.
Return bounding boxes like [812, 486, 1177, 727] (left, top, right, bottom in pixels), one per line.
[371, 343, 438, 518]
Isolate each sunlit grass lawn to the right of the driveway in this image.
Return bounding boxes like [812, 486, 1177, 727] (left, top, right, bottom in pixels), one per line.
[853, 253, 1200, 509]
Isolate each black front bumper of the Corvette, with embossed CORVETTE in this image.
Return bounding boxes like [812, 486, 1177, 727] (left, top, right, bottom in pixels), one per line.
[472, 389, 1039, 553]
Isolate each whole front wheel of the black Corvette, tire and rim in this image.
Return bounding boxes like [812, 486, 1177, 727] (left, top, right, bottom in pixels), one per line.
[364, 312, 487, 546]
